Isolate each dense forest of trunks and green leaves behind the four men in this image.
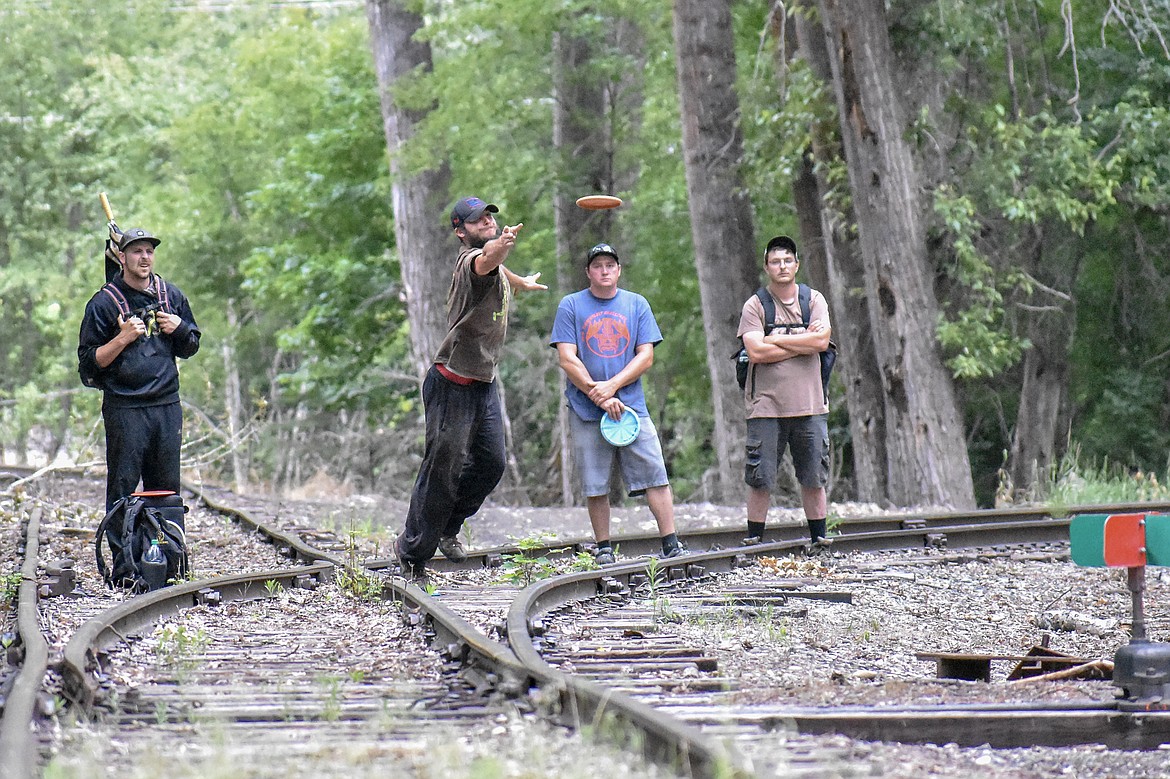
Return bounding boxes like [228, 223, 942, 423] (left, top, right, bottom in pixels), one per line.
[0, 0, 1170, 505]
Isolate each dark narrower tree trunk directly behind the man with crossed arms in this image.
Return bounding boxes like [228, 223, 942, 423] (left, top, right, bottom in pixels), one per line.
[793, 7, 889, 504]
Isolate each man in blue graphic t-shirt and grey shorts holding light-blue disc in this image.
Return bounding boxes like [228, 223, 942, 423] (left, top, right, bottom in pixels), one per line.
[550, 243, 687, 565]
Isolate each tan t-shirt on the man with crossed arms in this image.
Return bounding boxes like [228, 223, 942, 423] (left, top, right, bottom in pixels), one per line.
[736, 290, 830, 419]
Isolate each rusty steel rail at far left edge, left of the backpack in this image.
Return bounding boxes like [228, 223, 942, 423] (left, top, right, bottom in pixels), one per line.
[0, 508, 49, 779]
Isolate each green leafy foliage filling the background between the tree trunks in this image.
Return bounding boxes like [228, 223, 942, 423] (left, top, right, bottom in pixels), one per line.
[0, 0, 1170, 503]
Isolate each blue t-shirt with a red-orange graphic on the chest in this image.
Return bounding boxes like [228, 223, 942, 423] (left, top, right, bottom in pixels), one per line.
[549, 289, 662, 422]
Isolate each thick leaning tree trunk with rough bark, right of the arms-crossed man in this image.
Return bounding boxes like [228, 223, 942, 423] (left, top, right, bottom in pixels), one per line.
[820, 0, 975, 509]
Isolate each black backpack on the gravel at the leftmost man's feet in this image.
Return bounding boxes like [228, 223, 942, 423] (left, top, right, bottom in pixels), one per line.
[94, 492, 191, 592]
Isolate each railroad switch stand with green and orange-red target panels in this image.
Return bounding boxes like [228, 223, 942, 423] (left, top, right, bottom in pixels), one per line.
[1068, 513, 1170, 711]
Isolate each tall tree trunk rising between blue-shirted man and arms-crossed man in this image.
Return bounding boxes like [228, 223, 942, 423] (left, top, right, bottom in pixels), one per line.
[674, 0, 761, 501]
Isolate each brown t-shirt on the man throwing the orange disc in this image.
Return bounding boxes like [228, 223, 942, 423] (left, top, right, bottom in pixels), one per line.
[435, 248, 511, 381]
